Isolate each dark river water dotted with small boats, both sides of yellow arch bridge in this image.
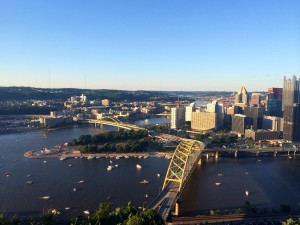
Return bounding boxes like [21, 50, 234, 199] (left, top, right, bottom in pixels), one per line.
[0, 117, 300, 218]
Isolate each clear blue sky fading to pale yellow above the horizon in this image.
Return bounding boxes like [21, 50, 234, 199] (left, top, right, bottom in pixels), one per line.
[0, 0, 300, 91]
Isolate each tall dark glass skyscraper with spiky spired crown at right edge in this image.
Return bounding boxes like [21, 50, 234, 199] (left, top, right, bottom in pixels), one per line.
[282, 76, 300, 142]
